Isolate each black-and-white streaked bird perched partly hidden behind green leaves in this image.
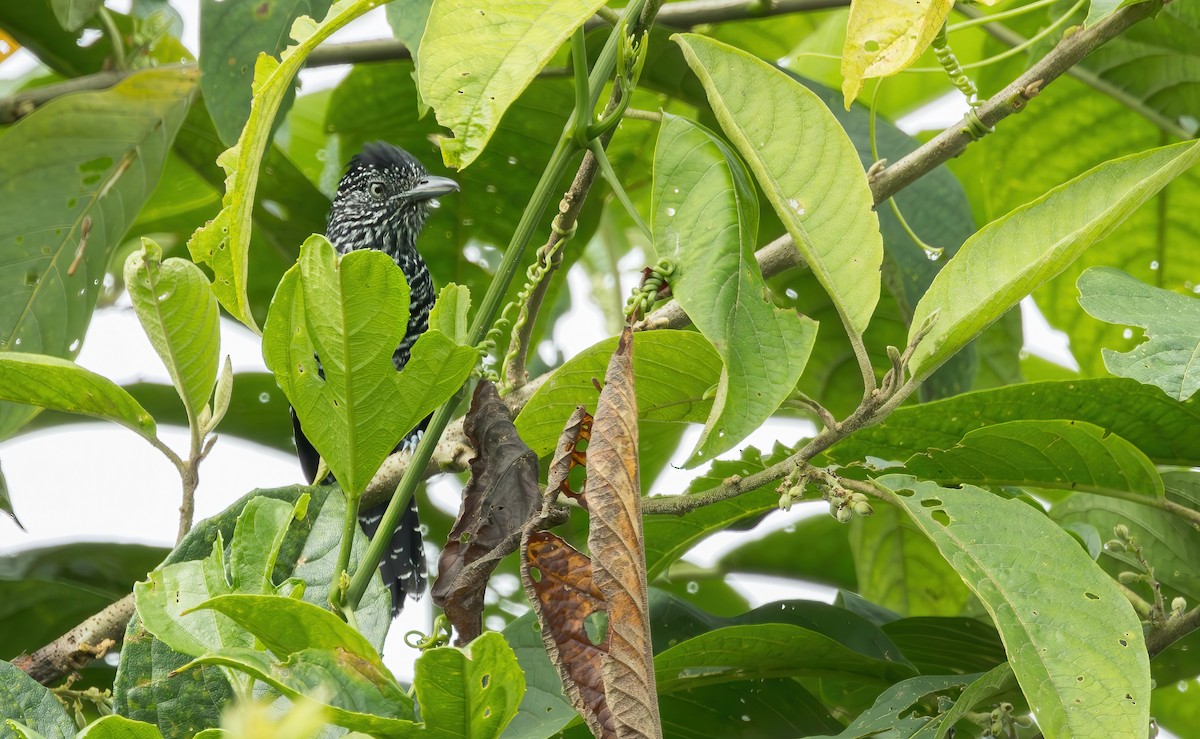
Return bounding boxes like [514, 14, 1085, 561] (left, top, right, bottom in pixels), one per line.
[292, 142, 458, 615]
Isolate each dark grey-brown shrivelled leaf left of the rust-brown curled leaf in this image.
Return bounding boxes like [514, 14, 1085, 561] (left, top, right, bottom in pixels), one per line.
[431, 380, 541, 644]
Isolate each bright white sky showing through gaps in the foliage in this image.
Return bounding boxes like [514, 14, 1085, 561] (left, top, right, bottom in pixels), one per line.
[0, 0, 1074, 679]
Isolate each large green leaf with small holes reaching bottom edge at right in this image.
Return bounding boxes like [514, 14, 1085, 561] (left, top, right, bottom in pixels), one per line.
[877, 475, 1150, 737]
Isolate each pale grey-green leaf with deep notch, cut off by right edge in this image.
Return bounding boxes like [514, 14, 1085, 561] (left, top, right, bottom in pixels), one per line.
[1079, 268, 1200, 401]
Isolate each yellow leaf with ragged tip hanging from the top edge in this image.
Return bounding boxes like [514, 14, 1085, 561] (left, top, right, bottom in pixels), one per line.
[841, 0, 954, 110]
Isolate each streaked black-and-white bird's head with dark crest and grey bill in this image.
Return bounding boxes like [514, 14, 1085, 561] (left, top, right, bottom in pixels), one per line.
[328, 142, 458, 259]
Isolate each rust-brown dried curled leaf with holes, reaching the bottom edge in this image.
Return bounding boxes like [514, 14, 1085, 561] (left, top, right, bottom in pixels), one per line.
[521, 328, 662, 738]
